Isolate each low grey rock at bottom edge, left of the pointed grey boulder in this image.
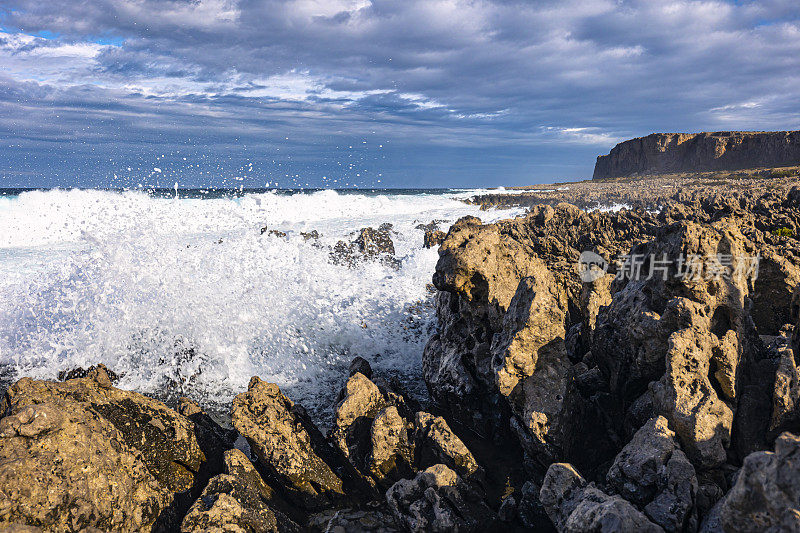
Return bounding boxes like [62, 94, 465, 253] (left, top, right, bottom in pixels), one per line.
[539, 463, 664, 533]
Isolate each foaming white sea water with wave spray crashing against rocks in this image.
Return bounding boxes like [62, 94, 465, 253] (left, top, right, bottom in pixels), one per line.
[0, 190, 515, 418]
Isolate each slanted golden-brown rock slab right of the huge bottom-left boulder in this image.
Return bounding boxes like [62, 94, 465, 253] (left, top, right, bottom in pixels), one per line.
[231, 377, 365, 511]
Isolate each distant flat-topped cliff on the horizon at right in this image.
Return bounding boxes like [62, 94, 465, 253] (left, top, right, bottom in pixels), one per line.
[594, 131, 800, 178]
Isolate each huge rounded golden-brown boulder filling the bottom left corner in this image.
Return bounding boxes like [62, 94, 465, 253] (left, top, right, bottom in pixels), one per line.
[0, 368, 205, 531]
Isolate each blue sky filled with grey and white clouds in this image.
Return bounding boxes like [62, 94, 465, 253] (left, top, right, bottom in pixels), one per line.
[0, 0, 800, 188]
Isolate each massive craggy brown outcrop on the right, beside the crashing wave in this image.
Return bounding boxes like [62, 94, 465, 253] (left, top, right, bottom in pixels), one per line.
[423, 185, 800, 532]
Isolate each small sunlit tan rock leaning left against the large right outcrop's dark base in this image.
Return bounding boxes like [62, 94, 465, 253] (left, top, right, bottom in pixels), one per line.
[414, 412, 480, 477]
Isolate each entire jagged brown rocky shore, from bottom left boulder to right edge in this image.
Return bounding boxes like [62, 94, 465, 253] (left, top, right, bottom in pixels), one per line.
[0, 178, 800, 533]
